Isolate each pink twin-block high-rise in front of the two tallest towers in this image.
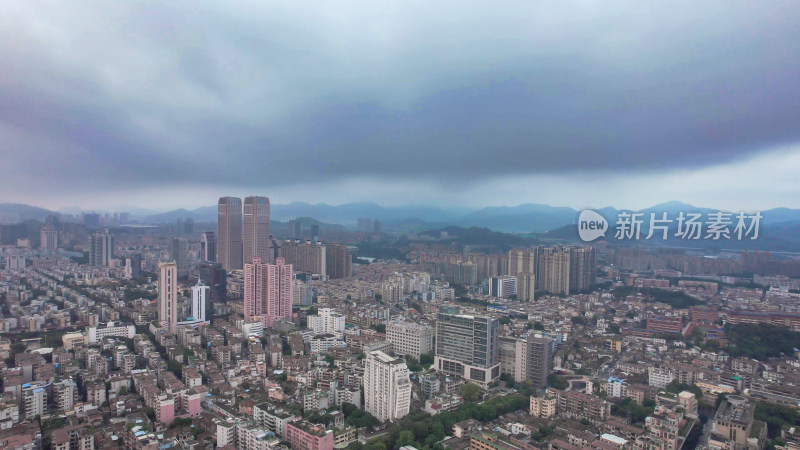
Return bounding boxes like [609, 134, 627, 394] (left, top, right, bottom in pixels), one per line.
[244, 256, 292, 327]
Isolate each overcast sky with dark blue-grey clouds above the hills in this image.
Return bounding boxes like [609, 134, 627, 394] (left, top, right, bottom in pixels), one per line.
[0, 0, 800, 209]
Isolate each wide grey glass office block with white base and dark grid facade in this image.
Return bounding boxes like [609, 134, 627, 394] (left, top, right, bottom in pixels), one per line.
[433, 308, 500, 387]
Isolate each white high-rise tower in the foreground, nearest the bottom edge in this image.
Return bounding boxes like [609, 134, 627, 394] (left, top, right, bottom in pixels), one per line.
[364, 350, 411, 422]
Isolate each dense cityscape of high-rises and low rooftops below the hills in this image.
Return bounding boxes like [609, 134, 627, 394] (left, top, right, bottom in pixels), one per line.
[0, 196, 800, 450]
